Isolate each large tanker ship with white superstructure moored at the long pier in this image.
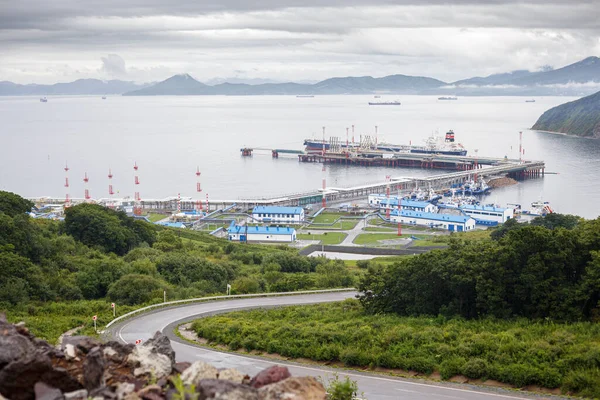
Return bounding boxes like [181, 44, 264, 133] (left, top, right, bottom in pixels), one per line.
[304, 130, 467, 156]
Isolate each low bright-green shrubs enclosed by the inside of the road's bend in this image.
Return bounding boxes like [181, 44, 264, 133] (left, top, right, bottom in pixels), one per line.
[193, 300, 600, 397]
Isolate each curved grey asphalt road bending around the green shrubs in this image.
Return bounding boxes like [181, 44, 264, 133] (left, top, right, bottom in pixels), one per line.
[108, 292, 558, 400]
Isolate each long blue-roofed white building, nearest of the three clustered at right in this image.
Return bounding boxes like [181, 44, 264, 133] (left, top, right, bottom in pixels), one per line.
[390, 210, 475, 232]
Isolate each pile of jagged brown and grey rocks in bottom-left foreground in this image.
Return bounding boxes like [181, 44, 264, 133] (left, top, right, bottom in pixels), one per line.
[0, 314, 326, 400]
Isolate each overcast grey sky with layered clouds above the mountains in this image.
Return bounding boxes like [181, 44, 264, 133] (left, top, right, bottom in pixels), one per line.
[0, 0, 600, 83]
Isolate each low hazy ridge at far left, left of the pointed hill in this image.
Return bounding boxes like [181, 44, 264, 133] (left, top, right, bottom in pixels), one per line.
[0, 79, 147, 96]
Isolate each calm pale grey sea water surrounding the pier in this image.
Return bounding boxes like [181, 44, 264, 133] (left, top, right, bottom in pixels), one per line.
[0, 96, 600, 218]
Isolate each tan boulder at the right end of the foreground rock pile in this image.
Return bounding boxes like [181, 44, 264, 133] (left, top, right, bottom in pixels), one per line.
[258, 376, 327, 400]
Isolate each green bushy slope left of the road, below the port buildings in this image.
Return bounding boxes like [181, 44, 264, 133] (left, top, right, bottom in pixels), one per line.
[0, 192, 356, 340]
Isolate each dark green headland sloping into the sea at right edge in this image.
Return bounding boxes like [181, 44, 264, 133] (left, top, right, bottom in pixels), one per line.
[531, 92, 600, 138]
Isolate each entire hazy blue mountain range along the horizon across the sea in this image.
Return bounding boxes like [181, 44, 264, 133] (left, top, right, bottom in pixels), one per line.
[0, 57, 600, 96]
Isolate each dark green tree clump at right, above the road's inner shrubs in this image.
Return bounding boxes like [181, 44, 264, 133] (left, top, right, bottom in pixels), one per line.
[359, 215, 600, 321]
